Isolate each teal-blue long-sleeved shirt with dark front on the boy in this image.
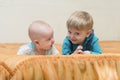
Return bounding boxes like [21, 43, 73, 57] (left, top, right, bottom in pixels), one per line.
[62, 31, 102, 55]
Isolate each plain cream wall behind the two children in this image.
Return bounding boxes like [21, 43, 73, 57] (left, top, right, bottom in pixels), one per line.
[0, 0, 120, 43]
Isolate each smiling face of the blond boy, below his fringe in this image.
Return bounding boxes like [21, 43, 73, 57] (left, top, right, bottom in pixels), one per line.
[68, 28, 90, 44]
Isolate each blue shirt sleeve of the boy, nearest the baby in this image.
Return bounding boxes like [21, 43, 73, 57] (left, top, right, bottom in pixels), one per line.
[62, 37, 72, 55]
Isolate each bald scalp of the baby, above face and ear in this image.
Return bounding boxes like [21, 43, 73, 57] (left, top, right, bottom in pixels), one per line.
[28, 20, 53, 41]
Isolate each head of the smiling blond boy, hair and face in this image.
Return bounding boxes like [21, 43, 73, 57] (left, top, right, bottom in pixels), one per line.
[67, 11, 93, 44]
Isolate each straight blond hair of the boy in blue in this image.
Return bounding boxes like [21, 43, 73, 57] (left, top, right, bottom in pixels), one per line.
[67, 11, 93, 30]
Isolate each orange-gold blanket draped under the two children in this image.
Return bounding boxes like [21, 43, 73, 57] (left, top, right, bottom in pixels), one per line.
[0, 41, 120, 80]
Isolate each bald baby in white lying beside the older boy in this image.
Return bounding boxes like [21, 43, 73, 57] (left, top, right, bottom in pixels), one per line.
[17, 20, 59, 55]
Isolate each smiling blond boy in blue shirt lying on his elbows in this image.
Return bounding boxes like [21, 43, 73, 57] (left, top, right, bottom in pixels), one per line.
[62, 11, 102, 55]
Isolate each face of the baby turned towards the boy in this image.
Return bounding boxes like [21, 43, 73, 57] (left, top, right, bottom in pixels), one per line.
[39, 31, 54, 50]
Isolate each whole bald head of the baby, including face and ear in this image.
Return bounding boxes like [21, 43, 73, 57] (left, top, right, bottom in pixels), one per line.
[28, 20, 54, 50]
